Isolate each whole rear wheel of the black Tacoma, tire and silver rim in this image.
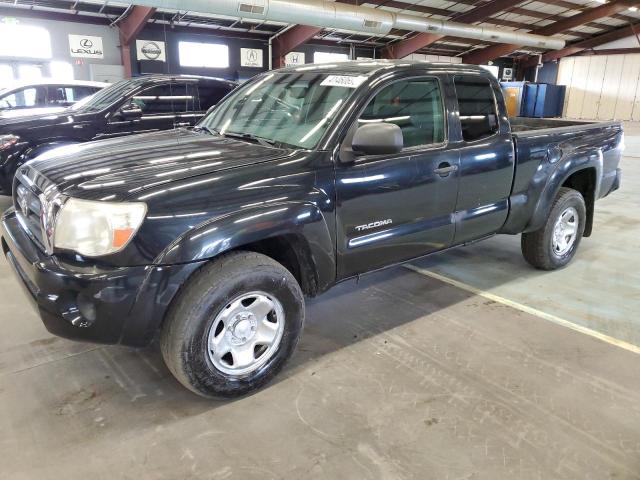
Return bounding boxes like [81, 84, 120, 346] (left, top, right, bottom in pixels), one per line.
[521, 187, 587, 270]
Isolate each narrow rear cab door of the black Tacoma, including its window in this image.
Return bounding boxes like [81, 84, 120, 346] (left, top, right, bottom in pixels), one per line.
[453, 71, 515, 245]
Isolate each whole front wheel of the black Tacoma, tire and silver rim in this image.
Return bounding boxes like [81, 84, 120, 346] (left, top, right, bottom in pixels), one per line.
[161, 252, 304, 398]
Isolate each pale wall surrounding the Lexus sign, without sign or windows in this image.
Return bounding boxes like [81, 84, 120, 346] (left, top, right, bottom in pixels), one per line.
[0, 15, 122, 80]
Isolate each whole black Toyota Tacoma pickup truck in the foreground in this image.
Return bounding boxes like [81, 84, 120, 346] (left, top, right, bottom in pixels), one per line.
[2, 61, 624, 397]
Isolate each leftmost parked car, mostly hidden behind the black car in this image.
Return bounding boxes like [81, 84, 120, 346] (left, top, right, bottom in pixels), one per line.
[0, 80, 109, 115]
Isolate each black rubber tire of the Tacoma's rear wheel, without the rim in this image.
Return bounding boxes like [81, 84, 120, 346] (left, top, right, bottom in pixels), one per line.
[521, 187, 587, 270]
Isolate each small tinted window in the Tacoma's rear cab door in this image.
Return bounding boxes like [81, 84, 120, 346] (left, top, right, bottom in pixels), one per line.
[454, 77, 500, 142]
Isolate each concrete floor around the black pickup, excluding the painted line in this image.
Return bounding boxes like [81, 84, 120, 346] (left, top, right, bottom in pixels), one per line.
[0, 124, 640, 480]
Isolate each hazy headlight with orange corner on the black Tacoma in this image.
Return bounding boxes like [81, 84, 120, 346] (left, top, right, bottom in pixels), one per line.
[53, 198, 147, 257]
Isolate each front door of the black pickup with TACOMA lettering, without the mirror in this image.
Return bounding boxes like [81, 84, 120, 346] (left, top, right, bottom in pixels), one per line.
[336, 76, 459, 278]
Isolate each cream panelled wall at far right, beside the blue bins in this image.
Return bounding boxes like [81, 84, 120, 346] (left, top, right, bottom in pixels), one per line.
[557, 54, 640, 121]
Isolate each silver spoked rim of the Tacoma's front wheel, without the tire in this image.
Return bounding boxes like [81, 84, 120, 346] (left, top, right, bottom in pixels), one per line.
[207, 292, 285, 376]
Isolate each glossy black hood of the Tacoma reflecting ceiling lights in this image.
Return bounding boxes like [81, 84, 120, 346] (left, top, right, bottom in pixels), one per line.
[29, 129, 289, 200]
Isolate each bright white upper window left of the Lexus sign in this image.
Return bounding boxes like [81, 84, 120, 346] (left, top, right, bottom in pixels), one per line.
[0, 23, 51, 58]
